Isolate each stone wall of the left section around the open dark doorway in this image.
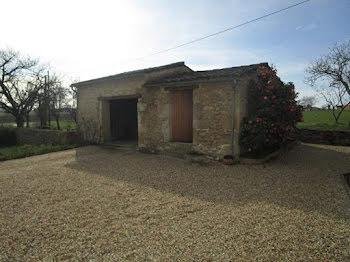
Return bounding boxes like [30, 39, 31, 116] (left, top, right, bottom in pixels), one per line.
[77, 66, 190, 143]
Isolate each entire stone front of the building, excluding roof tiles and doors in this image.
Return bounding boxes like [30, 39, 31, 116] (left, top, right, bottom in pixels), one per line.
[76, 64, 266, 157]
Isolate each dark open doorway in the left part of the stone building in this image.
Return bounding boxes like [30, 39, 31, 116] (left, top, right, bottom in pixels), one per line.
[110, 99, 137, 141]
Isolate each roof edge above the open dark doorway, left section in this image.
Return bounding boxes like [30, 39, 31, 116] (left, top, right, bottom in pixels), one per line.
[72, 62, 190, 86]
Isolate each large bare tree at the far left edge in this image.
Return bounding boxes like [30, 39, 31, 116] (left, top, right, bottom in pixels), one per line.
[0, 49, 44, 127]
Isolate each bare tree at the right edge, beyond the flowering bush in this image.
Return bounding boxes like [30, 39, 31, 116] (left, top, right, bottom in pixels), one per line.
[306, 40, 350, 125]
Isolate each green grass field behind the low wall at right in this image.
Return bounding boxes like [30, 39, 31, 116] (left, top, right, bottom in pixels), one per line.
[298, 110, 350, 131]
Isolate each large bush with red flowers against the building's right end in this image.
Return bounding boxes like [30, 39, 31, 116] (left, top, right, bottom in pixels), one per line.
[240, 67, 303, 157]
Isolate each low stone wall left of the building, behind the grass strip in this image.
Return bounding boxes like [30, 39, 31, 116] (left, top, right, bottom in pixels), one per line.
[14, 128, 80, 145]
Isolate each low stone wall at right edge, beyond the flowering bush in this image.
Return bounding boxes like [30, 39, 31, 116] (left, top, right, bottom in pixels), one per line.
[299, 129, 350, 146]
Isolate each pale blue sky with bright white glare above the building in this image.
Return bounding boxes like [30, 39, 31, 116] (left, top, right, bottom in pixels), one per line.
[0, 0, 350, 105]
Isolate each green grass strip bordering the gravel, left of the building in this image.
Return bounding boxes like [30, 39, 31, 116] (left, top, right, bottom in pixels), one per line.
[0, 145, 75, 161]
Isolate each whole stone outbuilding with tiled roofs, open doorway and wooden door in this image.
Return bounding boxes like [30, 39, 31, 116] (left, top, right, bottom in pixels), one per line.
[73, 62, 269, 158]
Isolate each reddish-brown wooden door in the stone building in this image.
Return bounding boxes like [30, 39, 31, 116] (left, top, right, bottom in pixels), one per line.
[172, 90, 193, 142]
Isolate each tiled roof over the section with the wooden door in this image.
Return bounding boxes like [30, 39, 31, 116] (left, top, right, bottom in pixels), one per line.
[143, 63, 268, 87]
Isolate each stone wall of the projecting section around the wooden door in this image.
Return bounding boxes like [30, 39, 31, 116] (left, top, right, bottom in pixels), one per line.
[138, 78, 247, 157]
